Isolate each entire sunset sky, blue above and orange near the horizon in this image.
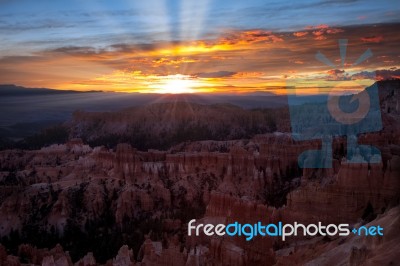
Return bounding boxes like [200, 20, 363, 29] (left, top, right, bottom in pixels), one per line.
[0, 0, 400, 94]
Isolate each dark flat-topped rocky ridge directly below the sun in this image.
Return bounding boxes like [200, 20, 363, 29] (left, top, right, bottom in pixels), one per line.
[66, 102, 275, 150]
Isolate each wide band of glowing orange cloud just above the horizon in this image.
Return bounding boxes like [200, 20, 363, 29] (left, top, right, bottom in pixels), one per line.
[0, 24, 400, 92]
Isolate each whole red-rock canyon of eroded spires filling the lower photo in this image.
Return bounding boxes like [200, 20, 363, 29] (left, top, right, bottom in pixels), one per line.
[0, 81, 400, 266]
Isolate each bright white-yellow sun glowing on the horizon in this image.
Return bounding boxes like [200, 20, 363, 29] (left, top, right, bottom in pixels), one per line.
[150, 74, 198, 94]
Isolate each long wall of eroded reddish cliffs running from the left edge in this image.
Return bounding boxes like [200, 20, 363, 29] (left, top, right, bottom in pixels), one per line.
[0, 132, 296, 230]
